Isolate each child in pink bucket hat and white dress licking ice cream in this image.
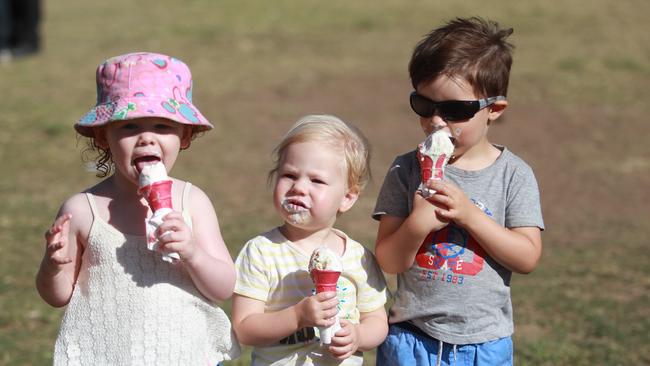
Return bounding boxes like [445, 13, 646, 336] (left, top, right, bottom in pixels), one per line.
[36, 53, 239, 365]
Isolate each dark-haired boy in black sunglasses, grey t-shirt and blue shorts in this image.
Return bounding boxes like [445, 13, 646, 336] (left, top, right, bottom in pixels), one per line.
[373, 18, 544, 365]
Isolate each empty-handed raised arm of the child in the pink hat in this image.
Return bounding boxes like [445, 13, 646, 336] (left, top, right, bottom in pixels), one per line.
[36, 195, 90, 307]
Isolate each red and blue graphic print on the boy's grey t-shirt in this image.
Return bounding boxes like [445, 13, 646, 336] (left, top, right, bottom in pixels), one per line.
[415, 199, 492, 278]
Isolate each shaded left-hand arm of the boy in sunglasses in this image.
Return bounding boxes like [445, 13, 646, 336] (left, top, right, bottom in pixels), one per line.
[375, 193, 447, 274]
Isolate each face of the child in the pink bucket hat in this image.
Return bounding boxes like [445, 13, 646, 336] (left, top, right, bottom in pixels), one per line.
[96, 117, 192, 185]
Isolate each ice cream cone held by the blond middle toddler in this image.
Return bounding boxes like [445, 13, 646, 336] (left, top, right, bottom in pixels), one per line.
[308, 246, 343, 344]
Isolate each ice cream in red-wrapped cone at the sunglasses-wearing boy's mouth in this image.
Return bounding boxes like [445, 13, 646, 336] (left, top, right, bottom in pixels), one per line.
[417, 130, 454, 198]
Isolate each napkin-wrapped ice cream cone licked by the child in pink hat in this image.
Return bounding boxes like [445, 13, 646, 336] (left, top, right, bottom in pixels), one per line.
[138, 162, 180, 262]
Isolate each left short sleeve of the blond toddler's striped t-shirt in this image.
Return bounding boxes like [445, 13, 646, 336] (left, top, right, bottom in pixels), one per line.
[235, 238, 270, 302]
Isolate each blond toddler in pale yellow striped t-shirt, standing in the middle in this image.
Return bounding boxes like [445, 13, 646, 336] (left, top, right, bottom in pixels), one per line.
[232, 116, 388, 365]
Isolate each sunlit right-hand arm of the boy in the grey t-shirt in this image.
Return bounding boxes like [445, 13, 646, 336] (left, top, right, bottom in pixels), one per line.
[432, 181, 542, 273]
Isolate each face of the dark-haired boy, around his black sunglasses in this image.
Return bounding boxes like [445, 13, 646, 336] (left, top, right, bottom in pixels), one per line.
[416, 75, 508, 157]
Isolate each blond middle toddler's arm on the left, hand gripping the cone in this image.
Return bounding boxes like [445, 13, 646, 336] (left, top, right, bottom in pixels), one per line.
[232, 291, 338, 346]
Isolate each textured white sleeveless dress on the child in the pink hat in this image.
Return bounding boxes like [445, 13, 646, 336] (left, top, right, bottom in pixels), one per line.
[54, 183, 239, 366]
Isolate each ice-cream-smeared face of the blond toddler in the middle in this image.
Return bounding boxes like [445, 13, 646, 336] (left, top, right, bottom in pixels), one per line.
[273, 142, 358, 230]
